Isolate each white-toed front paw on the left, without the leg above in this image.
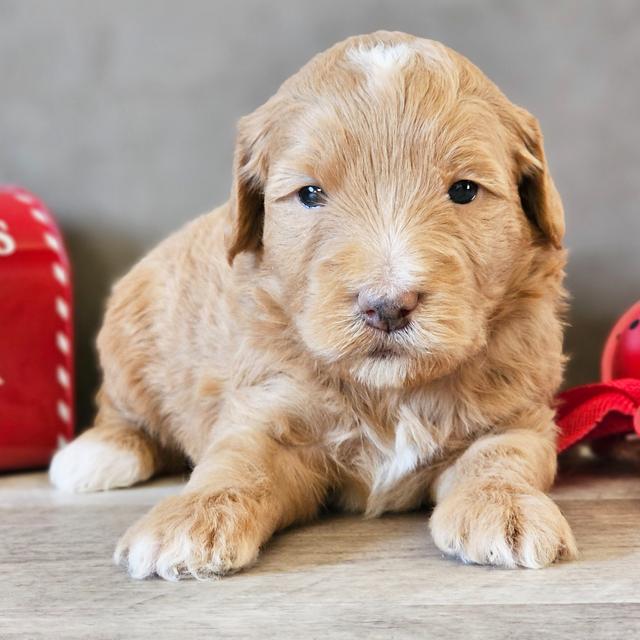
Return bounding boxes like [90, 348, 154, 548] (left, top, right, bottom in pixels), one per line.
[114, 491, 263, 580]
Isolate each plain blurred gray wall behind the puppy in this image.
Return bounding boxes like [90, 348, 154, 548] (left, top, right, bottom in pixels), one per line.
[0, 0, 640, 430]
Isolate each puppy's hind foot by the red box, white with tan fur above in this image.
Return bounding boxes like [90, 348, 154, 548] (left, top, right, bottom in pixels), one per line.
[49, 402, 161, 492]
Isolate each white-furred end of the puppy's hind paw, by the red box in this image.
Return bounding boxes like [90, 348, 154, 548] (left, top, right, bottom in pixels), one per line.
[49, 438, 146, 493]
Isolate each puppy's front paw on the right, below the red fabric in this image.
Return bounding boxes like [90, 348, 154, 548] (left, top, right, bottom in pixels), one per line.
[430, 483, 577, 569]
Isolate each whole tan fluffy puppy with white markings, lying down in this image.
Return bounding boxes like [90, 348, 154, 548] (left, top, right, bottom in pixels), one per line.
[50, 32, 576, 580]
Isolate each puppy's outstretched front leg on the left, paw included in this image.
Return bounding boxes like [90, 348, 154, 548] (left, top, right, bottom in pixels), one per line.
[114, 430, 327, 580]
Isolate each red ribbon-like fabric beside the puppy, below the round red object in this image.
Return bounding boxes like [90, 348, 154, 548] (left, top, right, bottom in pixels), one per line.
[557, 378, 640, 451]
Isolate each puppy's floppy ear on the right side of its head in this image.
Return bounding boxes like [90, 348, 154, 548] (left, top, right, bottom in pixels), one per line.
[514, 107, 564, 249]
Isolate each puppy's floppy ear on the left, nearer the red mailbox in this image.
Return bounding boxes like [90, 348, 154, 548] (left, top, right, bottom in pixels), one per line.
[225, 103, 270, 264]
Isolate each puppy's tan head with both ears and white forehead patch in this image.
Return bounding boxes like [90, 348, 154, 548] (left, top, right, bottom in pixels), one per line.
[228, 33, 563, 386]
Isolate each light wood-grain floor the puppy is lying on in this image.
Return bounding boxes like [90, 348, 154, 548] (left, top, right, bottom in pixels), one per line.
[0, 458, 640, 640]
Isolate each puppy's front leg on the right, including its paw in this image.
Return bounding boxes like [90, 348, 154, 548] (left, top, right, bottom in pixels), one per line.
[430, 430, 577, 568]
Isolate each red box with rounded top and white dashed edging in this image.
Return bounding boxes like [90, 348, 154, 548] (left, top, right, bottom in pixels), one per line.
[0, 187, 74, 470]
